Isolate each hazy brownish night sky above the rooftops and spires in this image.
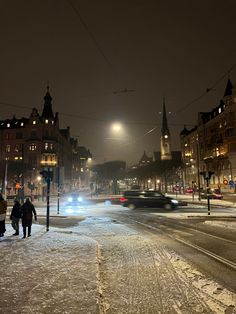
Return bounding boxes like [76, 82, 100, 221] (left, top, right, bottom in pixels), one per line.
[0, 0, 236, 164]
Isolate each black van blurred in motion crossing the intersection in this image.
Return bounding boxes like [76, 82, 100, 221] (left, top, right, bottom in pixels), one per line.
[120, 190, 179, 209]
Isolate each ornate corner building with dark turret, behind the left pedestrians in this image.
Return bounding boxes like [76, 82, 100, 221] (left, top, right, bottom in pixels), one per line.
[0, 87, 91, 199]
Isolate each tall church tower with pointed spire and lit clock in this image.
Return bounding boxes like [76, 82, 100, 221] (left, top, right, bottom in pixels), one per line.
[161, 98, 172, 160]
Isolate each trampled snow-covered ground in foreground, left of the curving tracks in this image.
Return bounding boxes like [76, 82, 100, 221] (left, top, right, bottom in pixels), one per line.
[0, 202, 236, 314]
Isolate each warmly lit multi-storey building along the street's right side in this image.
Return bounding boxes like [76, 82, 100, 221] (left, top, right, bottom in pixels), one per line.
[180, 80, 236, 191]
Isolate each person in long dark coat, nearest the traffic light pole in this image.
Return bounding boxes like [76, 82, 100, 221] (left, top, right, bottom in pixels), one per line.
[21, 198, 37, 238]
